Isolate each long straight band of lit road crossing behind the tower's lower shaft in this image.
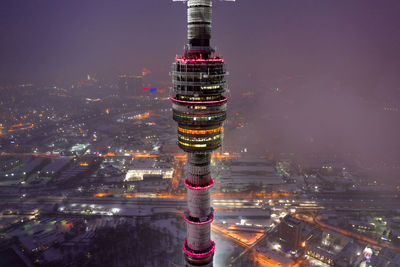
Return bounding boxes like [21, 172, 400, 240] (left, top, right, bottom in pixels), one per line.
[0, 191, 400, 212]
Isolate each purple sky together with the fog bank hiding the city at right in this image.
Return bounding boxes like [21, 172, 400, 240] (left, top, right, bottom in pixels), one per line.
[0, 0, 400, 172]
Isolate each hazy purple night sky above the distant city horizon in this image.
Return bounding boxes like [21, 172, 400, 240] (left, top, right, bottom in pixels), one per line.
[0, 0, 400, 86]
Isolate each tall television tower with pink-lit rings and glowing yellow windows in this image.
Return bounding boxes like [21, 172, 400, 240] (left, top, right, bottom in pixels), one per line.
[170, 0, 227, 267]
